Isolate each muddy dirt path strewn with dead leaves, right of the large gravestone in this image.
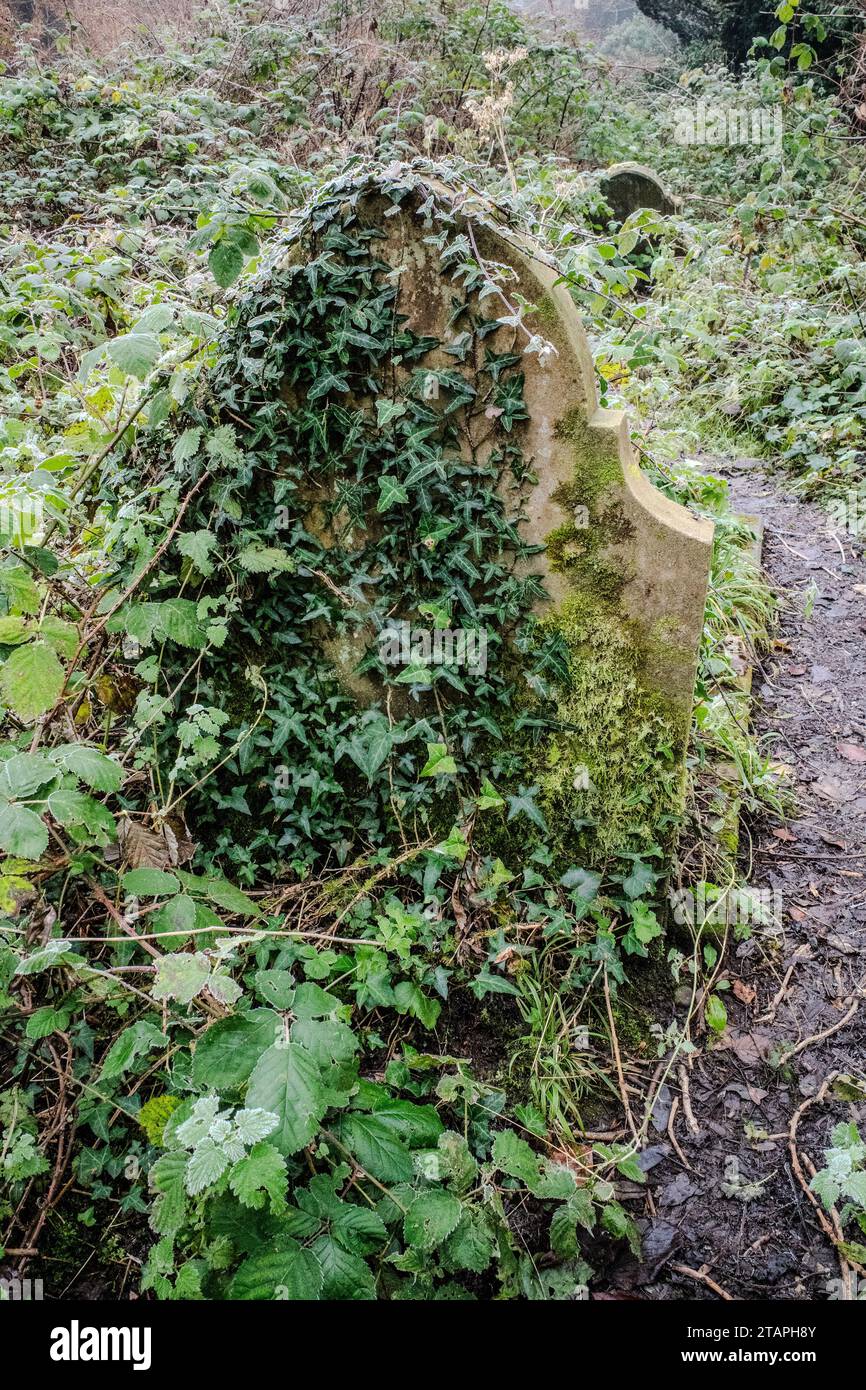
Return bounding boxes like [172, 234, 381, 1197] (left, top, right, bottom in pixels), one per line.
[625, 460, 866, 1300]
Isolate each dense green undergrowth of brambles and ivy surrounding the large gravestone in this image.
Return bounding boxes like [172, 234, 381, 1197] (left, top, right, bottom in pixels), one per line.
[0, 0, 866, 1298]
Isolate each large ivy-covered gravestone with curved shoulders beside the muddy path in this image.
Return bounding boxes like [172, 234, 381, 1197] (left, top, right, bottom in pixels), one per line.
[161, 165, 712, 869]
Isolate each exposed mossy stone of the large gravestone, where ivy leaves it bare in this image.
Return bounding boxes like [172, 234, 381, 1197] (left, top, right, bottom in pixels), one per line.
[262, 170, 713, 860]
